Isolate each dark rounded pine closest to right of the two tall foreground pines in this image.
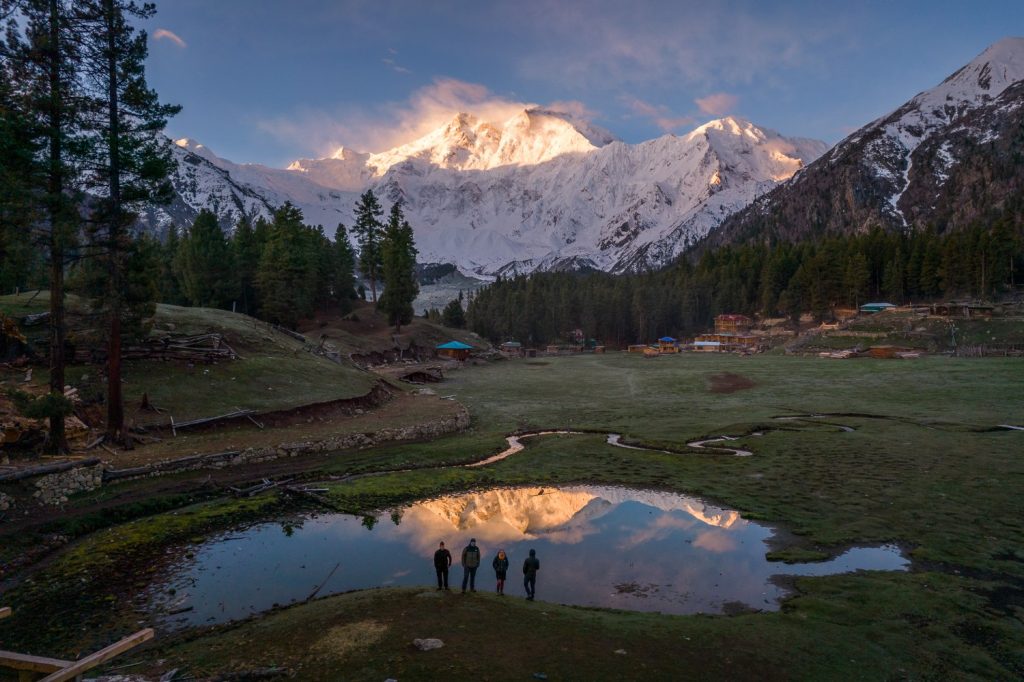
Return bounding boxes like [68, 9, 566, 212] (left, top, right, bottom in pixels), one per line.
[174, 209, 237, 308]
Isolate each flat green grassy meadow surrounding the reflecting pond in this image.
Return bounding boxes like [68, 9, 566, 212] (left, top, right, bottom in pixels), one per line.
[0, 353, 1024, 680]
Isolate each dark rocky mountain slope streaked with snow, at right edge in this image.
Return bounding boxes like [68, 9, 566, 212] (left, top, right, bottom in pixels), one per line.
[709, 38, 1024, 246]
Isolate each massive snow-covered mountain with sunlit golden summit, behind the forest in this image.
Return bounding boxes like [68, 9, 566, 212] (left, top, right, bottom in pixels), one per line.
[151, 109, 825, 276]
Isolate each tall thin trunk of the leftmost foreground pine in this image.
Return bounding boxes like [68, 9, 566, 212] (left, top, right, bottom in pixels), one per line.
[46, 0, 68, 455]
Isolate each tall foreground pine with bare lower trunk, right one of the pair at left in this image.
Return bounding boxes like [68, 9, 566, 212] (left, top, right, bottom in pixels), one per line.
[76, 0, 180, 444]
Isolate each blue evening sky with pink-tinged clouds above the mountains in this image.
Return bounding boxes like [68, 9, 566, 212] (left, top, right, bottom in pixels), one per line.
[141, 0, 1024, 167]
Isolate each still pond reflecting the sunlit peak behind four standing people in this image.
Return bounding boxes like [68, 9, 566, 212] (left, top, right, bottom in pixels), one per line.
[152, 485, 909, 626]
